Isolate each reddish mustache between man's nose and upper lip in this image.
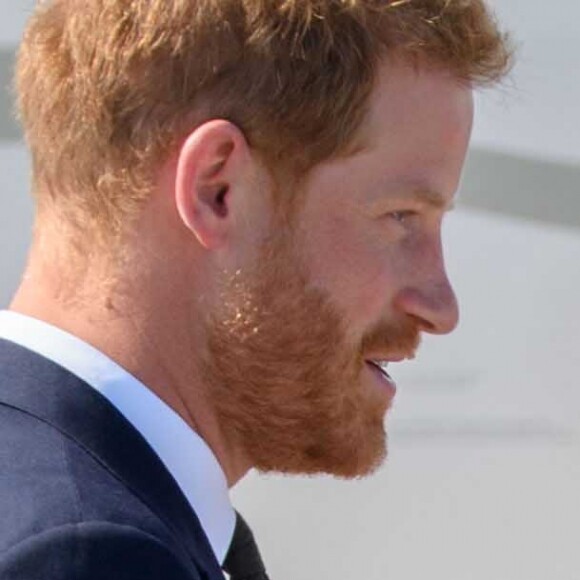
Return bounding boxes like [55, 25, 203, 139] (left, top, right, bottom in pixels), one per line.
[360, 319, 421, 358]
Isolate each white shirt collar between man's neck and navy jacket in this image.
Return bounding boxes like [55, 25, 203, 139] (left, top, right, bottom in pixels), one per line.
[0, 310, 235, 564]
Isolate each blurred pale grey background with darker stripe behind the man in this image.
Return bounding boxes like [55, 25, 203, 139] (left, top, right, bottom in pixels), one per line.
[0, 0, 580, 580]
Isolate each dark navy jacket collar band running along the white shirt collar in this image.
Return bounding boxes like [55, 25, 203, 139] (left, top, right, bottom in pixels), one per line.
[0, 339, 223, 579]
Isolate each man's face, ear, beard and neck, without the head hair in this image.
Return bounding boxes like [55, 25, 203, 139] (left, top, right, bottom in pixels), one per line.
[11, 57, 473, 485]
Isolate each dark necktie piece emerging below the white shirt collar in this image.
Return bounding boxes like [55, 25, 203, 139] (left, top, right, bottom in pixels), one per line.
[223, 512, 269, 580]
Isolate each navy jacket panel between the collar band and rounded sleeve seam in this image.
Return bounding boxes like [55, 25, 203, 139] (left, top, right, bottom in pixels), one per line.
[0, 405, 175, 556]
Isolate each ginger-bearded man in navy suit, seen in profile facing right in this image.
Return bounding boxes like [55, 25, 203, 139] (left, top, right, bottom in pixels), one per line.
[0, 0, 509, 580]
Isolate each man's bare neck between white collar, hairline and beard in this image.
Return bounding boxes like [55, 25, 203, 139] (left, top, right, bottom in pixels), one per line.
[10, 247, 251, 487]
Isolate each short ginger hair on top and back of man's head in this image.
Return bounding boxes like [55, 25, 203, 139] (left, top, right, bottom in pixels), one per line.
[16, 0, 510, 244]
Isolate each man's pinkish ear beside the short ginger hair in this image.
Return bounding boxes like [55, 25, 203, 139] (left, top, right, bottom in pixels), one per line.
[175, 119, 251, 249]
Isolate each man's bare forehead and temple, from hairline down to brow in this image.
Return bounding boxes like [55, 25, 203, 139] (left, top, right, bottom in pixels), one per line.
[296, 61, 473, 218]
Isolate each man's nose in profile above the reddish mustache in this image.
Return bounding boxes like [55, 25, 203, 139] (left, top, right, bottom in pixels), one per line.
[395, 274, 459, 334]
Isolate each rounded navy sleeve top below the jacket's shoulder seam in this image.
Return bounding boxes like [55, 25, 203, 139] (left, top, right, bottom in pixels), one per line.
[0, 521, 200, 580]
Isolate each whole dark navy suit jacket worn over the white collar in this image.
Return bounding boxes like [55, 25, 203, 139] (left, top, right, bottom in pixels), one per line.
[0, 339, 224, 580]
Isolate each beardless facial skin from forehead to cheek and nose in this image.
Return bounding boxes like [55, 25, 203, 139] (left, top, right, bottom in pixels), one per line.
[294, 63, 473, 344]
